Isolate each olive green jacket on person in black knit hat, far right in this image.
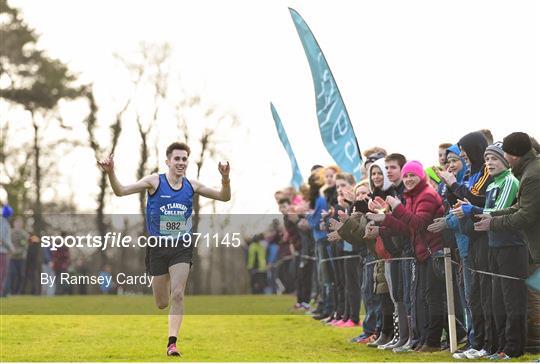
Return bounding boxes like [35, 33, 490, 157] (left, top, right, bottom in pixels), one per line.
[490, 149, 540, 264]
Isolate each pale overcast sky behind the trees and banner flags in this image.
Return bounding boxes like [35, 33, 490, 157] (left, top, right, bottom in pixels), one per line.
[5, 0, 540, 213]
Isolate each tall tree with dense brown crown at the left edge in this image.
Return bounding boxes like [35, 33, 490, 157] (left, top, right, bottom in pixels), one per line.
[0, 0, 81, 234]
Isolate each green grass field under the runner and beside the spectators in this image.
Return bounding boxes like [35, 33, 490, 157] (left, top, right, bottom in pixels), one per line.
[0, 296, 536, 362]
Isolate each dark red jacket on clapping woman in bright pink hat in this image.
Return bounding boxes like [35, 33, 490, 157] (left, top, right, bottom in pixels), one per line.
[381, 180, 444, 262]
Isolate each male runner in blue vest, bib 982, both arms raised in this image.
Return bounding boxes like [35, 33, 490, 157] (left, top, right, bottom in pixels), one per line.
[98, 142, 231, 356]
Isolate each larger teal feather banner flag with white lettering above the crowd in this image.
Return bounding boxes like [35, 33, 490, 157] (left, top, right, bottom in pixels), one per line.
[289, 8, 362, 181]
